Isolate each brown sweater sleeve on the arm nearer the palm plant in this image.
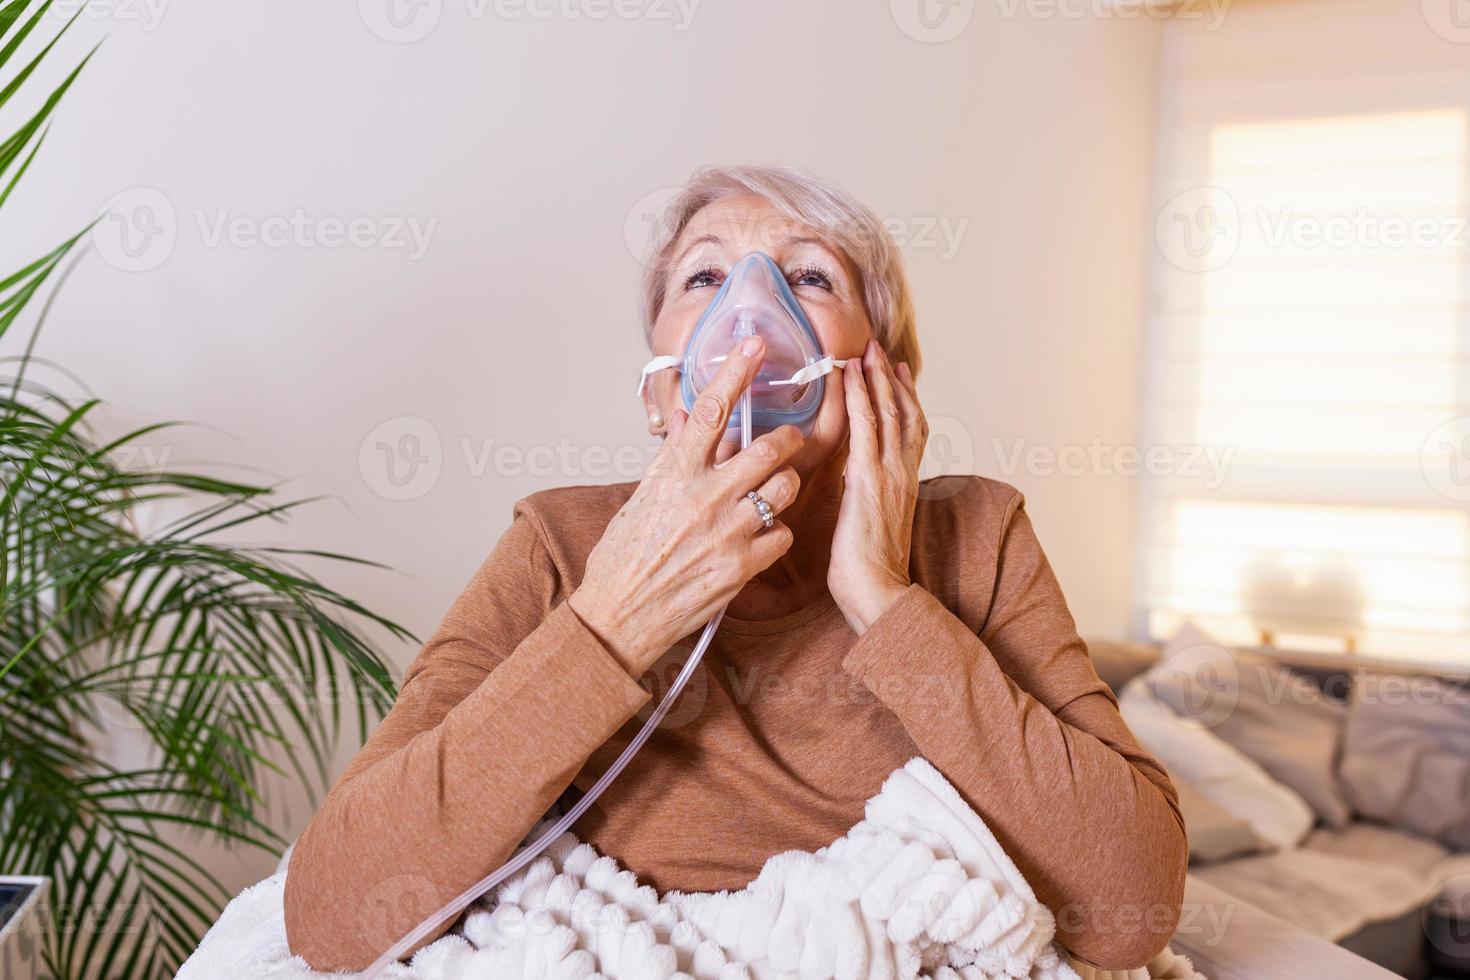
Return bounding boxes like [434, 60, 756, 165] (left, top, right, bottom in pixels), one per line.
[285, 508, 648, 970]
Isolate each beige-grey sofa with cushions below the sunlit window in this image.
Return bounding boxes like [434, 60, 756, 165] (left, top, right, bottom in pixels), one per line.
[1088, 633, 1470, 980]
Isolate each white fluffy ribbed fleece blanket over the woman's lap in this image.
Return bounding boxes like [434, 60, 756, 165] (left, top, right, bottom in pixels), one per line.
[178, 758, 1204, 980]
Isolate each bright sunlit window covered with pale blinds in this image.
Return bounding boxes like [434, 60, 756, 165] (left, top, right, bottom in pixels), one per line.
[1141, 76, 1470, 663]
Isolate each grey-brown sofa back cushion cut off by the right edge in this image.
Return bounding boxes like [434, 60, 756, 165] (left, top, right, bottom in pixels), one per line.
[1338, 674, 1470, 849]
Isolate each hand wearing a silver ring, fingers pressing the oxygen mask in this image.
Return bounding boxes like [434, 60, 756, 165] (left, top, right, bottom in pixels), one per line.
[567, 336, 803, 677]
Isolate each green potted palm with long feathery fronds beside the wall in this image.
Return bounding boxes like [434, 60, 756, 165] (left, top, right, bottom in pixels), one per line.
[0, 0, 407, 980]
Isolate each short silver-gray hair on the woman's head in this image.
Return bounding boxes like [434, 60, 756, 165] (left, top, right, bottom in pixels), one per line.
[642, 165, 919, 376]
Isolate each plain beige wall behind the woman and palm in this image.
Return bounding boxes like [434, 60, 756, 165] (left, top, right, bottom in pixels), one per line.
[4, 0, 1160, 884]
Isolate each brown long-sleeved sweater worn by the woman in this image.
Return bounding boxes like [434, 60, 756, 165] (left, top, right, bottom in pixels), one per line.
[285, 478, 1186, 970]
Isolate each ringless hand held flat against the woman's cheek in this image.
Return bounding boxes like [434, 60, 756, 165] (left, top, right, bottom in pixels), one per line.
[828, 341, 929, 636]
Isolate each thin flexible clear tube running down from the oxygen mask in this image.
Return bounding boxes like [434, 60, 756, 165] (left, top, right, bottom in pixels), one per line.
[362, 388, 751, 980]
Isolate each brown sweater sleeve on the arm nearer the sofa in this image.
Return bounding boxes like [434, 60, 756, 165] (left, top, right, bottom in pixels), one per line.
[844, 494, 1188, 968]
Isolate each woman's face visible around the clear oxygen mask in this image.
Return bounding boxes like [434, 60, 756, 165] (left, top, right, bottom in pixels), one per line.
[644, 194, 873, 476]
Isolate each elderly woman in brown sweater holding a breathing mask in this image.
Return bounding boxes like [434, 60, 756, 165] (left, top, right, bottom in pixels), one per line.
[285, 167, 1186, 970]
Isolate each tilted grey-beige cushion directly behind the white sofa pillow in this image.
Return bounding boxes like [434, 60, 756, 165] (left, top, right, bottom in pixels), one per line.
[1148, 624, 1352, 827]
